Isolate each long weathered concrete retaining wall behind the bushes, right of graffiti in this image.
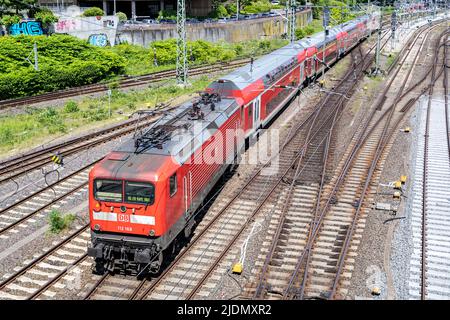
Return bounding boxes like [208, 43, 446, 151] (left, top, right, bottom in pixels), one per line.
[117, 10, 312, 47]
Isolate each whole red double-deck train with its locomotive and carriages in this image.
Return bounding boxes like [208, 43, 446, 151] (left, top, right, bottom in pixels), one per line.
[88, 12, 381, 274]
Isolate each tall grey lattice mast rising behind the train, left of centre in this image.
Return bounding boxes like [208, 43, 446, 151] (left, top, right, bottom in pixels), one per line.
[177, 0, 188, 86]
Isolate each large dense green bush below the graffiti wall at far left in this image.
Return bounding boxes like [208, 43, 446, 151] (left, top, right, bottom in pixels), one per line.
[0, 35, 125, 99]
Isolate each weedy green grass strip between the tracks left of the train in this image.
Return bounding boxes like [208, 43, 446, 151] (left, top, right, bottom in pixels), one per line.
[0, 76, 211, 155]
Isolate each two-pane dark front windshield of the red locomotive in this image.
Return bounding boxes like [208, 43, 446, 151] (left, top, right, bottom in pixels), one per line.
[94, 179, 155, 204]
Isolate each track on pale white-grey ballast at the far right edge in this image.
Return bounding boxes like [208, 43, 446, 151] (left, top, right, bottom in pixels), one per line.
[409, 27, 450, 300]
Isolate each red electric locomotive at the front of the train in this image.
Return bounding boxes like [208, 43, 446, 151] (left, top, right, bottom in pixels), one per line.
[88, 95, 243, 273]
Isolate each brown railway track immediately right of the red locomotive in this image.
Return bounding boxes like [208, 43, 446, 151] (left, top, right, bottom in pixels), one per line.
[108, 41, 376, 299]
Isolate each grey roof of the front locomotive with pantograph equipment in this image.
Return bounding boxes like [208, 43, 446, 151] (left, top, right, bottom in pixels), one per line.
[115, 93, 238, 164]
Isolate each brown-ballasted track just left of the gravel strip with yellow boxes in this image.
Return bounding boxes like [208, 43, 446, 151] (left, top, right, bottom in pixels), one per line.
[276, 21, 448, 299]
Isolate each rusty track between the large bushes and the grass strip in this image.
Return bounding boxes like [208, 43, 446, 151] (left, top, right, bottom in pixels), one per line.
[0, 59, 250, 110]
